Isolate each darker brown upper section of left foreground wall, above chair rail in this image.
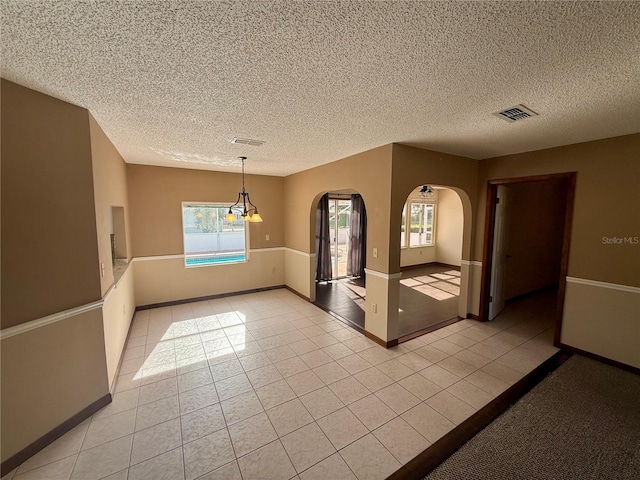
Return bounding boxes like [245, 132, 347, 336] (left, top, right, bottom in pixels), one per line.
[1, 79, 101, 328]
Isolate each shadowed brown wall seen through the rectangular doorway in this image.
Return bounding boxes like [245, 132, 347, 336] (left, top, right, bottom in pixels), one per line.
[504, 180, 568, 300]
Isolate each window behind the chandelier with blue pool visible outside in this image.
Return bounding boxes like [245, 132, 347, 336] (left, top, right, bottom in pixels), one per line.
[182, 203, 248, 267]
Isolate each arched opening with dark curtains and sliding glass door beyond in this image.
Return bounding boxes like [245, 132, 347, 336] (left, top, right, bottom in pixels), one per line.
[313, 190, 367, 331]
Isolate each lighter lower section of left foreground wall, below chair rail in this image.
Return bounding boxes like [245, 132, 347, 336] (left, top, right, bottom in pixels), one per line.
[0, 308, 109, 462]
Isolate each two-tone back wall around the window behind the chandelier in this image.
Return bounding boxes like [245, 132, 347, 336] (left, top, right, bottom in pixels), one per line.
[127, 165, 285, 305]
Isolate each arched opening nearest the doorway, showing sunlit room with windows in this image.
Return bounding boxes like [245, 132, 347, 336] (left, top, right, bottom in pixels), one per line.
[398, 184, 467, 341]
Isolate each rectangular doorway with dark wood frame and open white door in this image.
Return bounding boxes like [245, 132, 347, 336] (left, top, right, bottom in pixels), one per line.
[480, 172, 576, 345]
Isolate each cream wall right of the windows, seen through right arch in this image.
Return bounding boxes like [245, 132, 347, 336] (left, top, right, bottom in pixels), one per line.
[436, 188, 464, 267]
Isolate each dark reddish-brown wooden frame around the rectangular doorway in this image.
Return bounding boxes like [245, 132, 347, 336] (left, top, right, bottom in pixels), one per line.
[479, 172, 577, 347]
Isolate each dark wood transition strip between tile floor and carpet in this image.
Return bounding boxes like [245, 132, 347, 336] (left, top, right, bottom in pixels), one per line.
[387, 350, 572, 480]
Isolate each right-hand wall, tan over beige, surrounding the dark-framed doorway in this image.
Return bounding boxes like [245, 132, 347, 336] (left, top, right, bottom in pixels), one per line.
[472, 134, 640, 366]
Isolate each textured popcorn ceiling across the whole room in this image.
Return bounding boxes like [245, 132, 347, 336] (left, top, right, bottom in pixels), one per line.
[1, 0, 640, 175]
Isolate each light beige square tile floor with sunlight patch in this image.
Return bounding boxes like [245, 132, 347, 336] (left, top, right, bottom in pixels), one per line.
[3, 289, 557, 480]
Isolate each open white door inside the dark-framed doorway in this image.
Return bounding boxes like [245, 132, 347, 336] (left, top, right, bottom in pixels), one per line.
[489, 185, 509, 320]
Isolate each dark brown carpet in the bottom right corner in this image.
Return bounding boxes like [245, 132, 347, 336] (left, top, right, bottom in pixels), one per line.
[425, 355, 640, 480]
